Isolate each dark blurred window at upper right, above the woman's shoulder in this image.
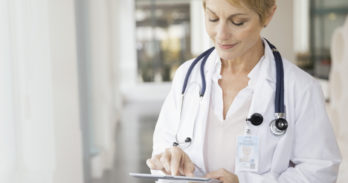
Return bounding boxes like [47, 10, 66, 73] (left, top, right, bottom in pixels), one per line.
[307, 0, 348, 79]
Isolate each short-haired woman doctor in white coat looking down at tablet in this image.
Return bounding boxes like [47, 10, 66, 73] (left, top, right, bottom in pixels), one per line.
[146, 0, 341, 183]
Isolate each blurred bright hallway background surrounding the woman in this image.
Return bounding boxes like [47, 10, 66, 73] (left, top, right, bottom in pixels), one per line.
[0, 0, 348, 183]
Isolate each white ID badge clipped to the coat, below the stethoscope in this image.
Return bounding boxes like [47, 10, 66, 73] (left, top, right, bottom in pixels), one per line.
[236, 135, 259, 172]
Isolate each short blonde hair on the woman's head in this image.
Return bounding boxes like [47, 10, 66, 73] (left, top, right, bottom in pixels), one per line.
[203, 0, 275, 24]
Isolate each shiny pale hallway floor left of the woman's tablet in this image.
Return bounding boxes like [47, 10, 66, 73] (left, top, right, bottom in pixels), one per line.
[92, 103, 160, 183]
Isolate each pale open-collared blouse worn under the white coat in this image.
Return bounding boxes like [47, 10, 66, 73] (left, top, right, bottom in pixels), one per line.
[205, 57, 264, 172]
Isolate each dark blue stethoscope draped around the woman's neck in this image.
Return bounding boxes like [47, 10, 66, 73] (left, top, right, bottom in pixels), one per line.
[173, 40, 288, 146]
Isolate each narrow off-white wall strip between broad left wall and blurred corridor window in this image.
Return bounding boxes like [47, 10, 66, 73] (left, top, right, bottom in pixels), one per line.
[88, 0, 119, 177]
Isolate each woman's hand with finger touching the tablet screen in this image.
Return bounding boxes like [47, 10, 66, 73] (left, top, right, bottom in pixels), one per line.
[146, 147, 195, 177]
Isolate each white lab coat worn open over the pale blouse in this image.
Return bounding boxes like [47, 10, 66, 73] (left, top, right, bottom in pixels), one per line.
[153, 42, 341, 183]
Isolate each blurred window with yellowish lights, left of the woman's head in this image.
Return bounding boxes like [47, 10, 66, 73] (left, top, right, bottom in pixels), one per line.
[135, 0, 193, 82]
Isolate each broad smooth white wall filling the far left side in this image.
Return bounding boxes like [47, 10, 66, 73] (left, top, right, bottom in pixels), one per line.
[0, 0, 83, 183]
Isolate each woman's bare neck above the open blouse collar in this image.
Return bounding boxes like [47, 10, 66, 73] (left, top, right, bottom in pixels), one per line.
[221, 40, 264, 75]
